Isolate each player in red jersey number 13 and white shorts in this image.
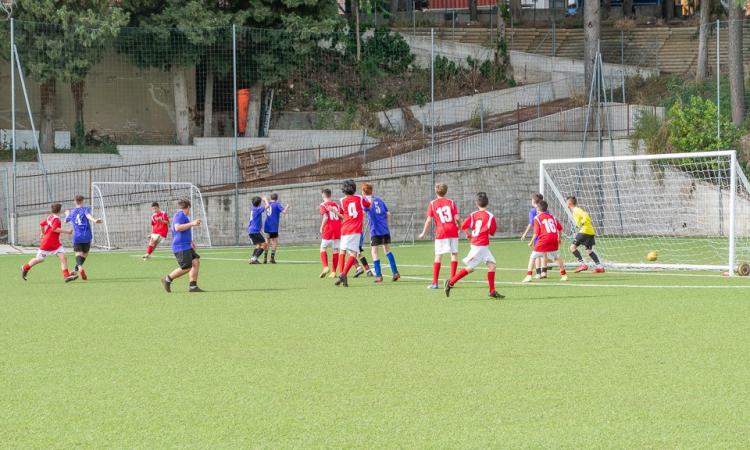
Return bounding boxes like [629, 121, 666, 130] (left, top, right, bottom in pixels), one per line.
[419, 183, 461, 289]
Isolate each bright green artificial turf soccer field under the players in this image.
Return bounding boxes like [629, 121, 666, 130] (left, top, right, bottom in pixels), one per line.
[0, 241, 750, 448]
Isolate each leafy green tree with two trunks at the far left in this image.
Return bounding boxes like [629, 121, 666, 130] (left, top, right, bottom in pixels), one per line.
[16, 0, 128, 152]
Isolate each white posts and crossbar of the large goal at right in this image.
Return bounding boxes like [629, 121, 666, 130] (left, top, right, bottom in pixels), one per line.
[539, 150, 750, 276]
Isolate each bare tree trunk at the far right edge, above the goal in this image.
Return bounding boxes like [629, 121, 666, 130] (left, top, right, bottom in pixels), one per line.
[728, 0, 745, 127]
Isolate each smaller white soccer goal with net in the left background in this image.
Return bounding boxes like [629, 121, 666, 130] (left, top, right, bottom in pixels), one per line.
[91, 182, 211, 250]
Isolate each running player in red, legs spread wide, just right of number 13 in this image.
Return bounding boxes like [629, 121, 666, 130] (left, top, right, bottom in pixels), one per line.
[445, 192, 505, 299]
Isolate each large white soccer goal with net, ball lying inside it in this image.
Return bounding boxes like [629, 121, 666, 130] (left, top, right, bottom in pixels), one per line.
[539, 151, 750, 274]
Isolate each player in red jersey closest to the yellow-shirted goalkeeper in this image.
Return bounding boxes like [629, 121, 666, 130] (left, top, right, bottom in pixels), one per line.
[523, 200, 568, 283]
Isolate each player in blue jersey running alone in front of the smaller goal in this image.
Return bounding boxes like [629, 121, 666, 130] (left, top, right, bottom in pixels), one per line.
[161, 199, 203, 292]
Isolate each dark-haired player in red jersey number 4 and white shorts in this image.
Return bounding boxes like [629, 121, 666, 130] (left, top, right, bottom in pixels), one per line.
[327, 180, 372, 287]
